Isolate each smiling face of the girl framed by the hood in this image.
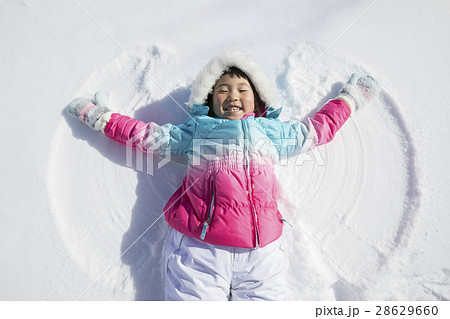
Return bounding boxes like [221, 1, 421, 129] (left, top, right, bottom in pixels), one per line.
[212, 74, 255, 120]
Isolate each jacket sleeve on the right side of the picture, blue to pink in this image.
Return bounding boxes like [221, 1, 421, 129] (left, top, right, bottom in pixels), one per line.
[266, 100, 351, 156]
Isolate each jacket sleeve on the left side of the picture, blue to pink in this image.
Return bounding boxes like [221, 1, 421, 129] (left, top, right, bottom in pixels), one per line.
[103, 113, 196, 155]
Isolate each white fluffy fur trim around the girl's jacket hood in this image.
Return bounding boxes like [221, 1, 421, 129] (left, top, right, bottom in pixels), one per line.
[187, 49, 276, 110]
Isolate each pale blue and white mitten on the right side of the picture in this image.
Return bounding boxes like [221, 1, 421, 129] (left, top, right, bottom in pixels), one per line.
[336, 73, 380, 114]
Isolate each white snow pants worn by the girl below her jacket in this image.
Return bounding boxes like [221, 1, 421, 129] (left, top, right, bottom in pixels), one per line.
[165, 229, 286, 300]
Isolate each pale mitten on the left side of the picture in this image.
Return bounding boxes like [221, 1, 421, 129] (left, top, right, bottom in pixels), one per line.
[65, 91, 111, 131]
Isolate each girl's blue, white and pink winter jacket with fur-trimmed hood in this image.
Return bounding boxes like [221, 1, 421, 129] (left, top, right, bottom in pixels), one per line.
[100, 50, 350, 248]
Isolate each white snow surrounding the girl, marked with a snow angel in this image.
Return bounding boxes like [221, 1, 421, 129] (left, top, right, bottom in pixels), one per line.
[0, 0, 450, 300]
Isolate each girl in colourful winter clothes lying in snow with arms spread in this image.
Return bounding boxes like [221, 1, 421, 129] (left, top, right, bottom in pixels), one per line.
[66, 50, 380, 300]
